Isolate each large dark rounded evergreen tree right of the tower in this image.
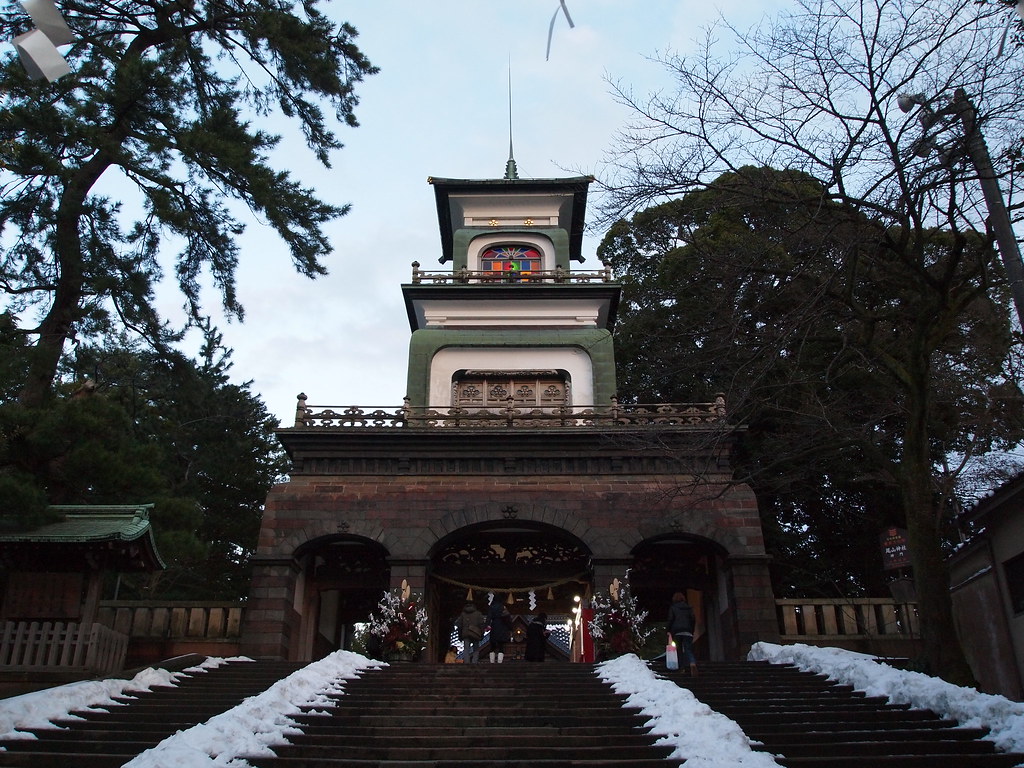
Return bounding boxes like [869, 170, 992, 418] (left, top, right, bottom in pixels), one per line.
[599, 168, 1024, 684]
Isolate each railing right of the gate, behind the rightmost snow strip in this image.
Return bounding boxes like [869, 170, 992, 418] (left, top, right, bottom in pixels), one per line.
[775, 597, 921, 644]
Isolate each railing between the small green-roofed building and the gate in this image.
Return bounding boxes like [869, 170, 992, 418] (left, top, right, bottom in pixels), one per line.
[97, 600, 244, 640]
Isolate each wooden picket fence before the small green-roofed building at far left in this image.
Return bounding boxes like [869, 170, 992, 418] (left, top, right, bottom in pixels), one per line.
[0, 622, 128, 673]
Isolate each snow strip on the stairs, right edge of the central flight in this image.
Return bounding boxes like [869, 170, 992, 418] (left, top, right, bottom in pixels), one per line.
[597, 653, 778, 768]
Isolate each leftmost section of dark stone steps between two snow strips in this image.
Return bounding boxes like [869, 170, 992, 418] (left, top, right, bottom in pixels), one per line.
[0, 657, 303, 768]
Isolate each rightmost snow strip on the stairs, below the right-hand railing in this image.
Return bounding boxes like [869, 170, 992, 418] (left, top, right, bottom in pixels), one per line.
[748, 643, 1024, 752]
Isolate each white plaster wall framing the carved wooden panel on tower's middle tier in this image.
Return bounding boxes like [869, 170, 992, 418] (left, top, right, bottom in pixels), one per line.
[429, 347, 594, 408]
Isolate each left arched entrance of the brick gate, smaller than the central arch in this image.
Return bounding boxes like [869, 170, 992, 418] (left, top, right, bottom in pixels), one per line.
[295, 535, 390, 659]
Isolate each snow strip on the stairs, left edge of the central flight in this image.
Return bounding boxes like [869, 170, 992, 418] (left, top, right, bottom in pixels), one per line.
[123, 650, 382, 768]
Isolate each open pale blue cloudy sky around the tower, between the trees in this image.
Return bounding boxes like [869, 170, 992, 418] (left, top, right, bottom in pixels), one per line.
[153, 0, 786, 426]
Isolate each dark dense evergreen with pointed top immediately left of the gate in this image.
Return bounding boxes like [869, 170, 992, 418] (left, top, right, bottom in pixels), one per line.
[75, 326, 288, 599]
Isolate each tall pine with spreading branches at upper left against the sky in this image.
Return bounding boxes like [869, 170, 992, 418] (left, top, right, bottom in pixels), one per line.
[0, 0, 376, 407]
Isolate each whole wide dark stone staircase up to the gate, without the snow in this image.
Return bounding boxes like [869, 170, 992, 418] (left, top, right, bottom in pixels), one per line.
[0, 662, 1024, 768]
